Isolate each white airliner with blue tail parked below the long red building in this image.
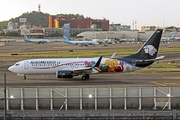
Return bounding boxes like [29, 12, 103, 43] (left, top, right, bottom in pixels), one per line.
[63, 35, 98, 47]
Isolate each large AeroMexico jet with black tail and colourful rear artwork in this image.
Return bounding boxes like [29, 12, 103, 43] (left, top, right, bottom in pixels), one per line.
[8, 29, 165, 80]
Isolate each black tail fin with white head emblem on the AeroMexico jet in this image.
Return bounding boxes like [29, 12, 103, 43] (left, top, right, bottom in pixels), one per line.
[128, 29, 163, 60]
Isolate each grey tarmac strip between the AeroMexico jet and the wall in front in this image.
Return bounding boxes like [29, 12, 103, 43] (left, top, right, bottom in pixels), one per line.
[0, 64, 180, 87]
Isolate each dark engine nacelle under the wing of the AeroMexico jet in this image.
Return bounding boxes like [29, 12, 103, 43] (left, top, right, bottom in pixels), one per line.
[56, 70, 73, 78]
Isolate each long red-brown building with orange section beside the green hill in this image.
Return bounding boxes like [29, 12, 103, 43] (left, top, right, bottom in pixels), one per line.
[48, 15, 109, 31]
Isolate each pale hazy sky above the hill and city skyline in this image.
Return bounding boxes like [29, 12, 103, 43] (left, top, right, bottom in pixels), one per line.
[0, 0, 180, 29]
